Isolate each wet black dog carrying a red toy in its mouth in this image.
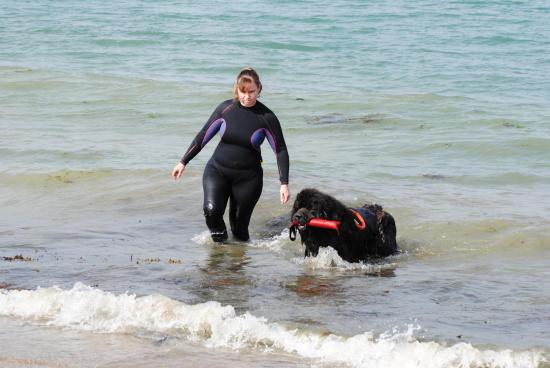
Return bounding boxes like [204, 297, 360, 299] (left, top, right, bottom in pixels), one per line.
[290, 189, 398, 262]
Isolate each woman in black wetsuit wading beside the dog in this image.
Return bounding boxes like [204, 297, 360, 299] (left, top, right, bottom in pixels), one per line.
[172, 68, 290, 242]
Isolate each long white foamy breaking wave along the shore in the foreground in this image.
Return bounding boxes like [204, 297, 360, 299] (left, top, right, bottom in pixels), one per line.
[0, 283, 548, 368]
